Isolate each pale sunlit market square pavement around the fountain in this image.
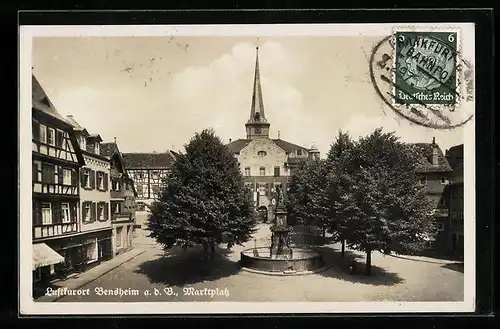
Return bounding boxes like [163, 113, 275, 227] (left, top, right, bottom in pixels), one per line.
[58, 225, 464, 302]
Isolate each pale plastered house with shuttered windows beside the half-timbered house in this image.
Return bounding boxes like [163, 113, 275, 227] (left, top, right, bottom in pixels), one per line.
[66, 115, 113, 266]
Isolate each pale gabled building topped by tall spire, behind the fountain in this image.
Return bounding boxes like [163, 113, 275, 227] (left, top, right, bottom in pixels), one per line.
[227, 47, 320, 221]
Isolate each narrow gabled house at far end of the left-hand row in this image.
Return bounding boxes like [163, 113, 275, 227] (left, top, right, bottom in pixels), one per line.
[101, 142, 136, 255]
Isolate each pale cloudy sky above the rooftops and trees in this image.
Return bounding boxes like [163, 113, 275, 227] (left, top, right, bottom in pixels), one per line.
[32, 36, 464, 157]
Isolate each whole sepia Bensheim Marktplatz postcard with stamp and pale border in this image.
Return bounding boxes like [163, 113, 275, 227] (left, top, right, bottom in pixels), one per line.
[19, 22, 476, 315]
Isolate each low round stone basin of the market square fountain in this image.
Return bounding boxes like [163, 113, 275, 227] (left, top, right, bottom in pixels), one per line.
[240, 247, 324, 273]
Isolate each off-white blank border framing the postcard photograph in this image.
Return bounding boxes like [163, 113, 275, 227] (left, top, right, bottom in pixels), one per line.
[19, 23, 476, 315]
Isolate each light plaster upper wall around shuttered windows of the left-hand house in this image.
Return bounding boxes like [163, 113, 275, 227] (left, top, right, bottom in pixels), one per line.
[80, 154, 111, 232]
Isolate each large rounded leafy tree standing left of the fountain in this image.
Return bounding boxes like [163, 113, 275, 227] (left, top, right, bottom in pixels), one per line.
[148, 129, 255, 258]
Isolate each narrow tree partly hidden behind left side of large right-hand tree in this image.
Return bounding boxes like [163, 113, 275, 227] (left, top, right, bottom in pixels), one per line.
[321, 131, 353, 257]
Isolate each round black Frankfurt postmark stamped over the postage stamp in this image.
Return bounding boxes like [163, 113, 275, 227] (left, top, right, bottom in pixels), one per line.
[370, 32, 473, 129]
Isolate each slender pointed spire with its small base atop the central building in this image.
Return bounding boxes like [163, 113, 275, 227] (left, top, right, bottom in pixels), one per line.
[245, 47, 271, 139]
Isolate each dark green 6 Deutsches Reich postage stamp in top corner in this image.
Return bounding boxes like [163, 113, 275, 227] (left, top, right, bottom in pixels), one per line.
[393, 30, 459, 106]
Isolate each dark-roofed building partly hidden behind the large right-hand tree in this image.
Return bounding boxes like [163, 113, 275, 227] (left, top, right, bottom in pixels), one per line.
[413, 138, 453, 254]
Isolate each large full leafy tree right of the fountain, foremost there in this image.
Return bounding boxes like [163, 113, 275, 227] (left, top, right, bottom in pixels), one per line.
[338, 129, 435, 275]
